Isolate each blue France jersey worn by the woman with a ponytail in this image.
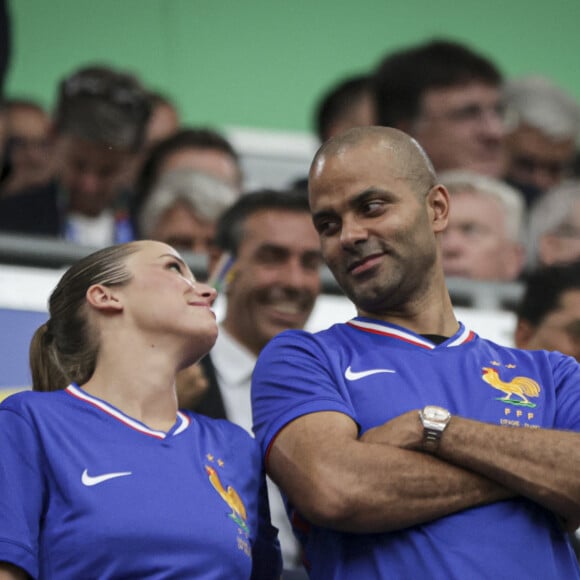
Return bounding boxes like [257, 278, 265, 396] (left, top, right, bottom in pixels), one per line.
[0, 385, 280, 580]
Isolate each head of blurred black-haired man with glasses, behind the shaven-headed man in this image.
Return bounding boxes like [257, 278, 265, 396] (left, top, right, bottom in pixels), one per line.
[375, 39, 504, 177]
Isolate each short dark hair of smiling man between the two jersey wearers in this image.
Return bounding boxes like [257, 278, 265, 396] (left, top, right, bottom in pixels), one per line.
[215, 189, 310, 256]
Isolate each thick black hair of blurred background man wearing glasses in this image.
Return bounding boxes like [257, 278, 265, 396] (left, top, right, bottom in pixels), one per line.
[374, 39, 502, 128]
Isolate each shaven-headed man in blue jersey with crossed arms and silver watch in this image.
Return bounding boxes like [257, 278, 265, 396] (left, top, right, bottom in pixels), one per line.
[252, 127, 580, 579]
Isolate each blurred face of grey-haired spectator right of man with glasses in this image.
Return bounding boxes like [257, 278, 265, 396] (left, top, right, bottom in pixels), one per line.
[505, 124, 575, 191]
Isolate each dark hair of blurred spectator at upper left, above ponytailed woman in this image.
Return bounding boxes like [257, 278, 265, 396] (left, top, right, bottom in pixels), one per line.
[54, 66, 151, 151]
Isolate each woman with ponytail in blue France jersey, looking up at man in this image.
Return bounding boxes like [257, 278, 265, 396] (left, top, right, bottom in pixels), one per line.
[0, 241, 280, 580]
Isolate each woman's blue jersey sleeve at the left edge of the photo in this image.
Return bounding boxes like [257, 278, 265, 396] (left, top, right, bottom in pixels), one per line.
[0, 402, 44, 578]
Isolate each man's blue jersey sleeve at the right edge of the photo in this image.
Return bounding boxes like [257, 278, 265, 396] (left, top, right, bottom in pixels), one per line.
[549, 352, 580, 431]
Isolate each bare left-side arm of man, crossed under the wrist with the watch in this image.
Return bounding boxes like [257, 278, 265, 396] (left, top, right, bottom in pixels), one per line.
[268, 413, 513, 532]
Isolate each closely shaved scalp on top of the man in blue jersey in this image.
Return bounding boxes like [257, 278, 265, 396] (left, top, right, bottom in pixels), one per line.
[309, 127, 436, 195]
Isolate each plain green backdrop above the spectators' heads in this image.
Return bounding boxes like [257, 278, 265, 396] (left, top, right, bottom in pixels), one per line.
[7, 0, 580, 131]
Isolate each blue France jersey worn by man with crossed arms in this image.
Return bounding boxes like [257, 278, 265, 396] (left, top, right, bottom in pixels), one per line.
[252, 317, 580, 580]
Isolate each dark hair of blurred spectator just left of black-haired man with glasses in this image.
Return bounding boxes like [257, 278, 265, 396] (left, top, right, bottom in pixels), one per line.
[314, 75, 372, 141]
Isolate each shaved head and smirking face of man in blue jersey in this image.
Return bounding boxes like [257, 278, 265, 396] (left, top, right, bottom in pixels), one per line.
[309, 127, 449, 316]
